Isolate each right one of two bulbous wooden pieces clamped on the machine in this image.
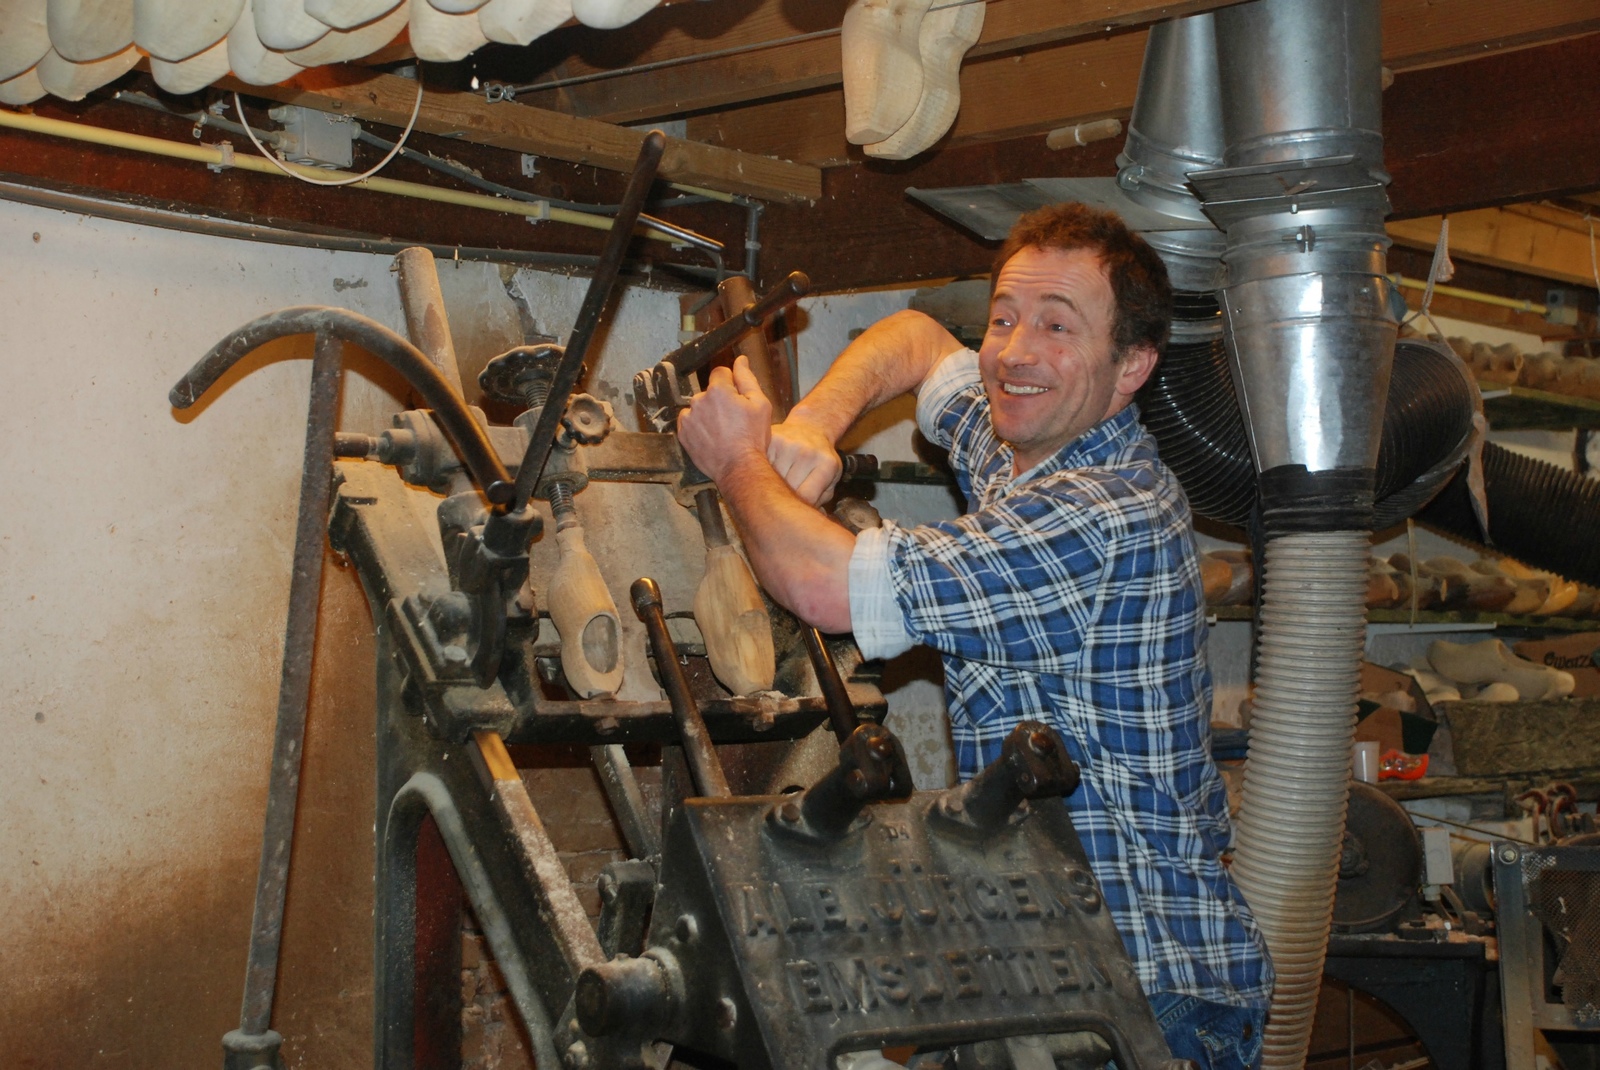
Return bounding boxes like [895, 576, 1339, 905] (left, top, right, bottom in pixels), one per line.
[694, 545, 778, 694]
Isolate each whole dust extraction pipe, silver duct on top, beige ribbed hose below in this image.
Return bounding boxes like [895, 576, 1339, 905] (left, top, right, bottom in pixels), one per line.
[1118, 0, 1395, 1068]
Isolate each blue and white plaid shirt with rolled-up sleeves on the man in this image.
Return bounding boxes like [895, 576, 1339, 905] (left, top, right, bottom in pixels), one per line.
[850, 350, 1272, 1008]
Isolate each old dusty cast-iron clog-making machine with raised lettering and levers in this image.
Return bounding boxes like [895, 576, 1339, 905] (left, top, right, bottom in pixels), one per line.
[171, 134, 1187, 1070]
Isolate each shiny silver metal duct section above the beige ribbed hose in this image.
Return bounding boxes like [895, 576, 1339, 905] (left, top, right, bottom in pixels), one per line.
[1189, 0, 1397, 533]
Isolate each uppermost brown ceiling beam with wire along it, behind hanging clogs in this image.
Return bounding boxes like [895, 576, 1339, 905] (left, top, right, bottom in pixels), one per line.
[517, 0, 1234, 123]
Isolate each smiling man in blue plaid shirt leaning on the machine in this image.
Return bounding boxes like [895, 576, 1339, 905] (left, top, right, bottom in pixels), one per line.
[678, 205, 1272, 1068]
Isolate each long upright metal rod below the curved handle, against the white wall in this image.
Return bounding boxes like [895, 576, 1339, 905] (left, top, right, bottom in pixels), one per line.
[238, 333, 344, 1035]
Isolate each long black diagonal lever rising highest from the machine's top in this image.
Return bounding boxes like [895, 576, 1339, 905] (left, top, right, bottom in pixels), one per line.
[510, 130, 667, 513]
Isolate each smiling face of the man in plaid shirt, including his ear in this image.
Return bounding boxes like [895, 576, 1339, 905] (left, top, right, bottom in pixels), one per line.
[978, 246, 1155, 473]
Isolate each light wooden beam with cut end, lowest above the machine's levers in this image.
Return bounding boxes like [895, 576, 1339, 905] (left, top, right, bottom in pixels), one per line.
[218, 67, 822, 202]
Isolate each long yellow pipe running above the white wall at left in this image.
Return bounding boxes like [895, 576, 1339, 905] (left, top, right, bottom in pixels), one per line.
[0, 109, 677, 243]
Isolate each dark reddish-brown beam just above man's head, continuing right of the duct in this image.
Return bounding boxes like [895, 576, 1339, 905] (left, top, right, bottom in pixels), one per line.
[762, 35, 1600, 291]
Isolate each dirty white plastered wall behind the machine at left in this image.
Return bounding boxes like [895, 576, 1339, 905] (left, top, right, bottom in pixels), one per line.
[0, 202, 677, 1070]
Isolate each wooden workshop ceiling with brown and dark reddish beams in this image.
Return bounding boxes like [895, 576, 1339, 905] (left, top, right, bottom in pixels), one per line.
[0, 0, 1600, 315]
